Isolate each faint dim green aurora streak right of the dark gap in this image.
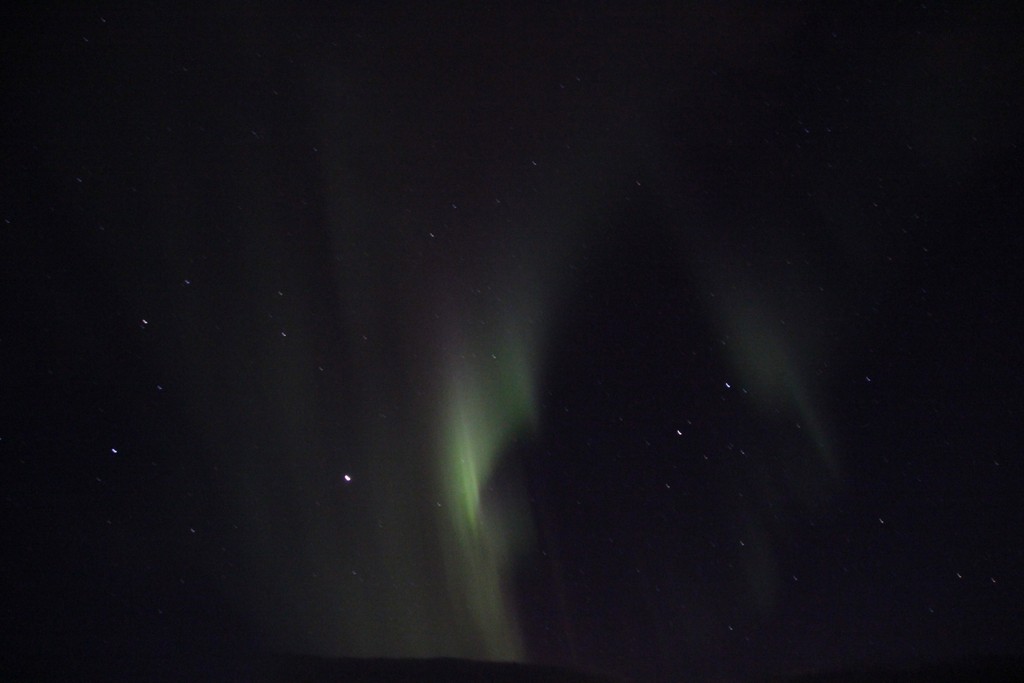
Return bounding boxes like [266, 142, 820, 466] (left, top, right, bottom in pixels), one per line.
[696, 258, 843, 610]
